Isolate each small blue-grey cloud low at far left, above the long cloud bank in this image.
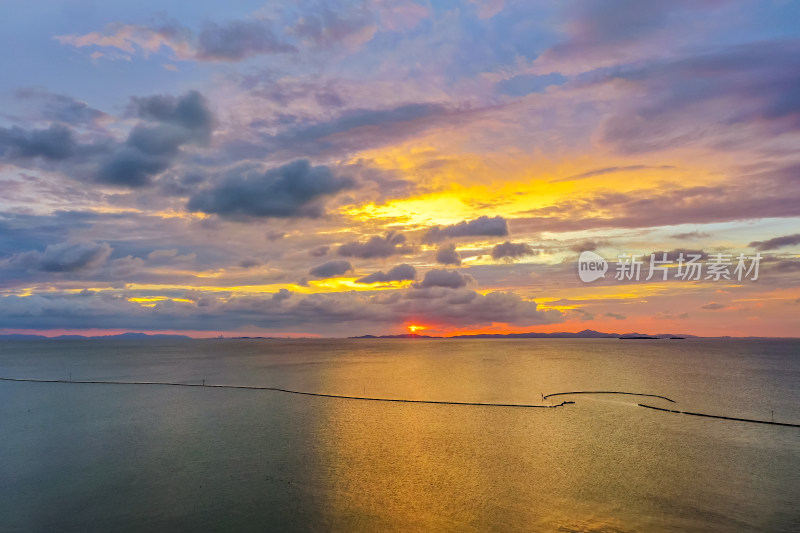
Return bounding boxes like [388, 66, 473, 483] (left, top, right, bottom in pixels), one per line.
[8, 241, 111, 272]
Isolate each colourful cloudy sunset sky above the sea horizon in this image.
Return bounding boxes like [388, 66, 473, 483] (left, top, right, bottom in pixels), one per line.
[0, 0, 800, 337]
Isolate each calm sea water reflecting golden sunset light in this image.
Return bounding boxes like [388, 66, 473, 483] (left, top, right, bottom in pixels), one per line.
[0, 339, 800, 532]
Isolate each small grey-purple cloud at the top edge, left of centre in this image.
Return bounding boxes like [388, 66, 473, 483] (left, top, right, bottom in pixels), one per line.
[196, 20, 297, 61]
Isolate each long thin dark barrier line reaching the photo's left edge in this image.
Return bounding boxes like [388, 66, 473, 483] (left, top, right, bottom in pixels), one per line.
[0, 377, 575, 409]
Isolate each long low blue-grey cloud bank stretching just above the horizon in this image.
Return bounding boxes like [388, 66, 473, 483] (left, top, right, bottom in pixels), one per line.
[0, 287, 563, 336]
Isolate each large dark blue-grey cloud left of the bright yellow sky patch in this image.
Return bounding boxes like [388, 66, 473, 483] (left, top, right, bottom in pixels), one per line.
[188, 159, 355, 218]
